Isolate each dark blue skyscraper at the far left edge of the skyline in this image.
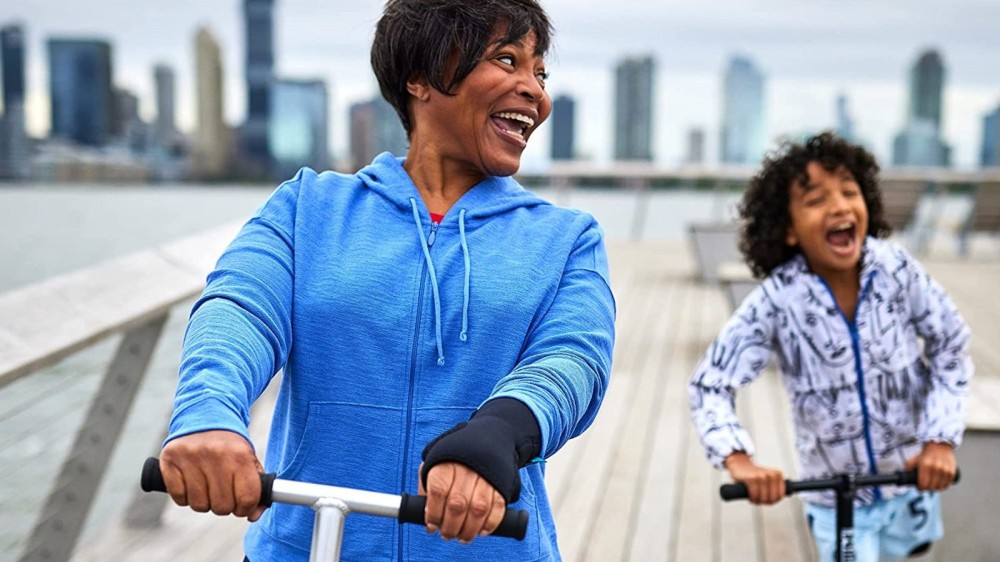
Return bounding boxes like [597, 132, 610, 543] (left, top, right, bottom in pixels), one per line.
[0, 25, 31, 179]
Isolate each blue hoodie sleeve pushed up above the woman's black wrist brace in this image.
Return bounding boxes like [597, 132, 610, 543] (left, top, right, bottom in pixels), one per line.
[490, 219, 615, 458]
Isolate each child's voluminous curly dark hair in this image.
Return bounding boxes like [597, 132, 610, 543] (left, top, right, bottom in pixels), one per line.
[739, 131, 892, 279]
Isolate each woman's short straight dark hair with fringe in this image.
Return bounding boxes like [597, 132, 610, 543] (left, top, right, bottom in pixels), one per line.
[371, 0, 552, 136]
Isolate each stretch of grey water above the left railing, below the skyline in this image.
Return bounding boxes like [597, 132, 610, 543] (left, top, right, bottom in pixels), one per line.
[0, 183, 271, 292]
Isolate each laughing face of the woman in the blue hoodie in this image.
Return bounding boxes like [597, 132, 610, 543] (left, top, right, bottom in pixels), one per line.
[412, 31, 552, 176]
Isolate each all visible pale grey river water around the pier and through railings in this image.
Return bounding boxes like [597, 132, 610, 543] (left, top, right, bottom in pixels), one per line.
[0, 180, 968, 559]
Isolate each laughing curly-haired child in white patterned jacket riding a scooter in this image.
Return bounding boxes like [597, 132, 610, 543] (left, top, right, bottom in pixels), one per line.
[689, 133, 972, 562]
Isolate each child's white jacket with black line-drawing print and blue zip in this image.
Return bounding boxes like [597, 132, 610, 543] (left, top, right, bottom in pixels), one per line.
[688, 237, 973, 505]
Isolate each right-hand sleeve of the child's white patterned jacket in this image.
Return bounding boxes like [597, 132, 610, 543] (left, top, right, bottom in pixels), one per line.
[906, 253, 973, 447]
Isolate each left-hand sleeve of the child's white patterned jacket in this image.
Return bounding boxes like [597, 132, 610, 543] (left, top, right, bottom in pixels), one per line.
[688, 281, 777, 468]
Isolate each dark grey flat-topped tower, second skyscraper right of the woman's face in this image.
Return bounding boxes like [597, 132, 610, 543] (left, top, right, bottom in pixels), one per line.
[615, 56, 655, 160]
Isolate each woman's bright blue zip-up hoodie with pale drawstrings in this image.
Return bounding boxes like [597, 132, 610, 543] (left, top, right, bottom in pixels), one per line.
[168, 153, 614, 562]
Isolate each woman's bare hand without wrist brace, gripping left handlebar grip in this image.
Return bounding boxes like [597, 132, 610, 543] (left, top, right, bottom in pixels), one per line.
[160, 430, 265, 522]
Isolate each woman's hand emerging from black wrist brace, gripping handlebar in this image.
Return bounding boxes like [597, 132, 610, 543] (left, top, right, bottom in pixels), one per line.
[417, 462, 507, 544]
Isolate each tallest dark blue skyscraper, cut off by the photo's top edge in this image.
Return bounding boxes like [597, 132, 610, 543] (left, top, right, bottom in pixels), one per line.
[243, 0, 274, 166]
